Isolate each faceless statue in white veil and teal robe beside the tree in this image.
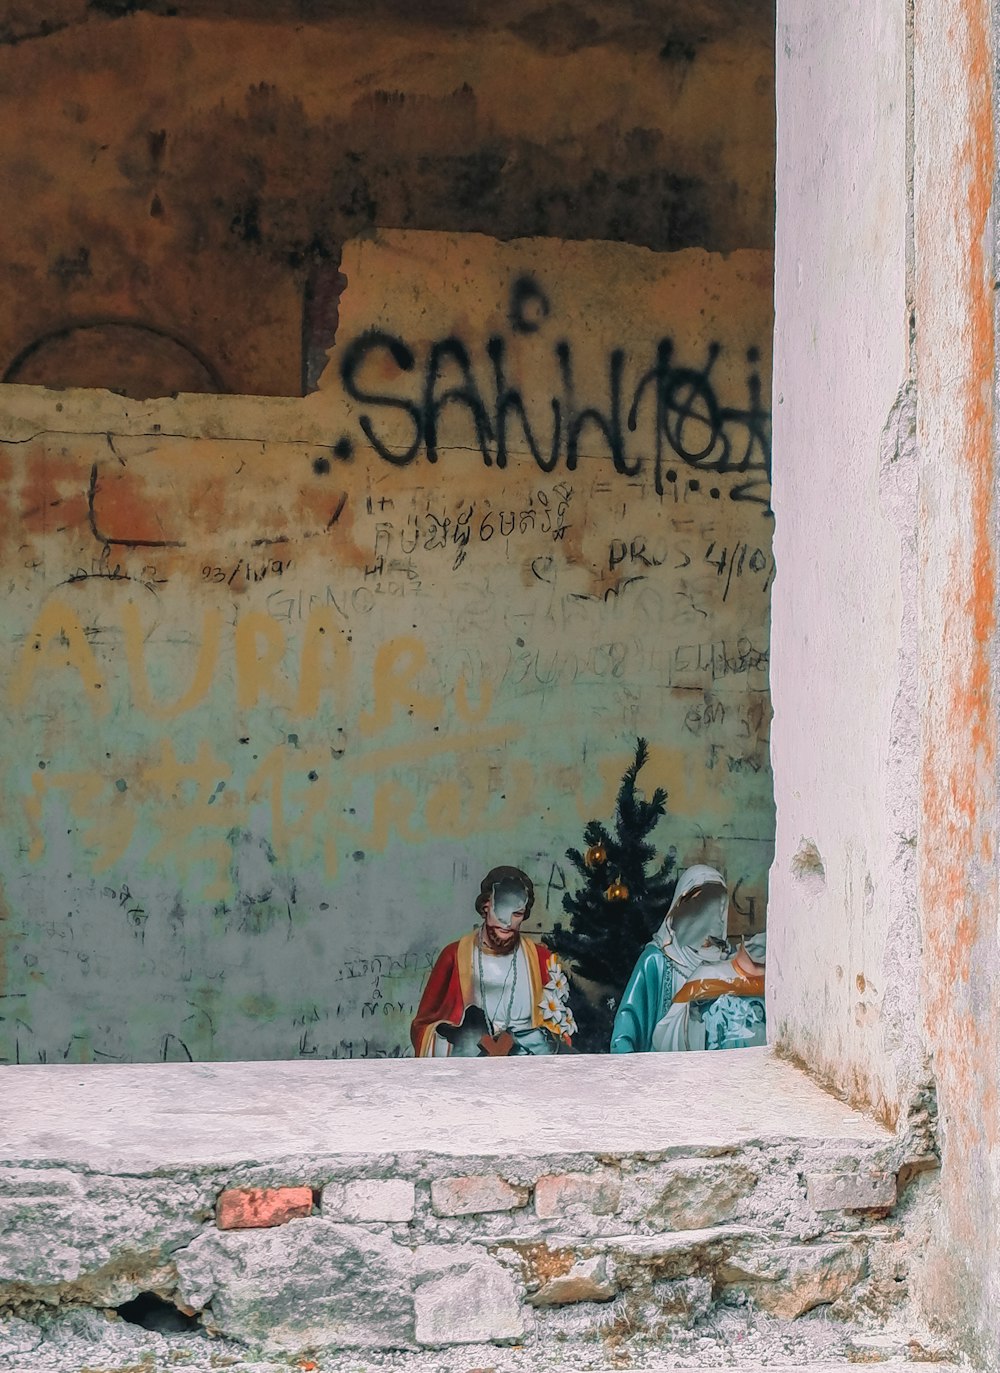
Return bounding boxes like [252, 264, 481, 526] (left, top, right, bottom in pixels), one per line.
[611, 864, 766, 1053]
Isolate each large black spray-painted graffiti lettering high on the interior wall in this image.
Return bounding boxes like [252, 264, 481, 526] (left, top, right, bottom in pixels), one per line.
[337, 277, 771, 512]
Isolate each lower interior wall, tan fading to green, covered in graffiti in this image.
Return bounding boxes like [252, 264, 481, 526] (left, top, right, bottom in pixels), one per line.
[0, 233, 773, 1061]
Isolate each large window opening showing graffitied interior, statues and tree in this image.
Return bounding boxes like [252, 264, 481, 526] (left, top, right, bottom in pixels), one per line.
[0, 4, 775, 1063]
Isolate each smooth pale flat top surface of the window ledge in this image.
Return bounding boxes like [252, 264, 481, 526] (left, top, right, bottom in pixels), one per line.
[0, 1049, 891, 1173]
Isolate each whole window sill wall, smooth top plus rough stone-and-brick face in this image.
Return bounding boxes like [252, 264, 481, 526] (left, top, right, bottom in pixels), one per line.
[0, 1049, 928, 1357]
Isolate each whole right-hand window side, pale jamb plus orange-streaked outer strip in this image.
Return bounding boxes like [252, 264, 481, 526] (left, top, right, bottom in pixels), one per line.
[769, 0, 1000, 1369]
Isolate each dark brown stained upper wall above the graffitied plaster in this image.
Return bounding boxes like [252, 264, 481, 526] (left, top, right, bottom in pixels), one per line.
[0, 0, 773, 395]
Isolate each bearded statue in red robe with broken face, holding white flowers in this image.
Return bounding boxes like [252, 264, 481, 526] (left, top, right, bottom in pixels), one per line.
[409, 866, 576, 1059]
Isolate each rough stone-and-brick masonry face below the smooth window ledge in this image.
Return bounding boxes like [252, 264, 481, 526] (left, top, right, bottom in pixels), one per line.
[0, 1141, 907, 1357]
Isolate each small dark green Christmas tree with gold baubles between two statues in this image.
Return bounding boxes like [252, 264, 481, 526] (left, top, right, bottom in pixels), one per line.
[552, 739, 677, 1053]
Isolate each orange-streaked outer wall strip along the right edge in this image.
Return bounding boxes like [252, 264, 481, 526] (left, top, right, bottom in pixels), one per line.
[915, 0, 1000, 1369]
